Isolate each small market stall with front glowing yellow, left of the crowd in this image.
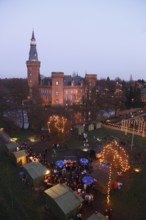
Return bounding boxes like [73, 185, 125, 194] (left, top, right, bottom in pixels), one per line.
[13, 150, 27, 165]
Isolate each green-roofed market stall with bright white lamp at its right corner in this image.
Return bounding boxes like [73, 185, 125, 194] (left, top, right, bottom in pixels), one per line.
[23, 162, 50, 189]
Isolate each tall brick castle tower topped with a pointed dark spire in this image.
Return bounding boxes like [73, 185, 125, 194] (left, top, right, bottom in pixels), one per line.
[26, 31, 40, 98]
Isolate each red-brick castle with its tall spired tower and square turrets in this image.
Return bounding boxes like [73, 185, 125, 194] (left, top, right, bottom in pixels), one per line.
[26, 31, 97, 105]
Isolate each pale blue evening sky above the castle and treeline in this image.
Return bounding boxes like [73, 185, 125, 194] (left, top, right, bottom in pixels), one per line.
[0, 0, 146, 80]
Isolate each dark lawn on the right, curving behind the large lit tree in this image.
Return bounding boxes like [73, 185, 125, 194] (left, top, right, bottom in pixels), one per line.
[89, 128, 146, 220]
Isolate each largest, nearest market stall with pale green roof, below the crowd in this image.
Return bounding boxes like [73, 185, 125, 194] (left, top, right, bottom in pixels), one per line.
[44, 184, 83, 220]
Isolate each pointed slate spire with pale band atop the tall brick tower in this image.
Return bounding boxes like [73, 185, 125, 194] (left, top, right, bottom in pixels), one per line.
[29, 30, 38, 61]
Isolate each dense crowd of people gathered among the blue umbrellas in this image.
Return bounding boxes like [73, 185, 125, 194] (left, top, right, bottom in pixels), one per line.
[44, 160, 94, 204]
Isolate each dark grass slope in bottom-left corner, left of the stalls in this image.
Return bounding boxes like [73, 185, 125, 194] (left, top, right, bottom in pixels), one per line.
[0, 141, 43, 220]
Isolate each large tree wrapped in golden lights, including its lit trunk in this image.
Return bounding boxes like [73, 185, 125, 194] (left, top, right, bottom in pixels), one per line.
[101, 140, 130, 206]
